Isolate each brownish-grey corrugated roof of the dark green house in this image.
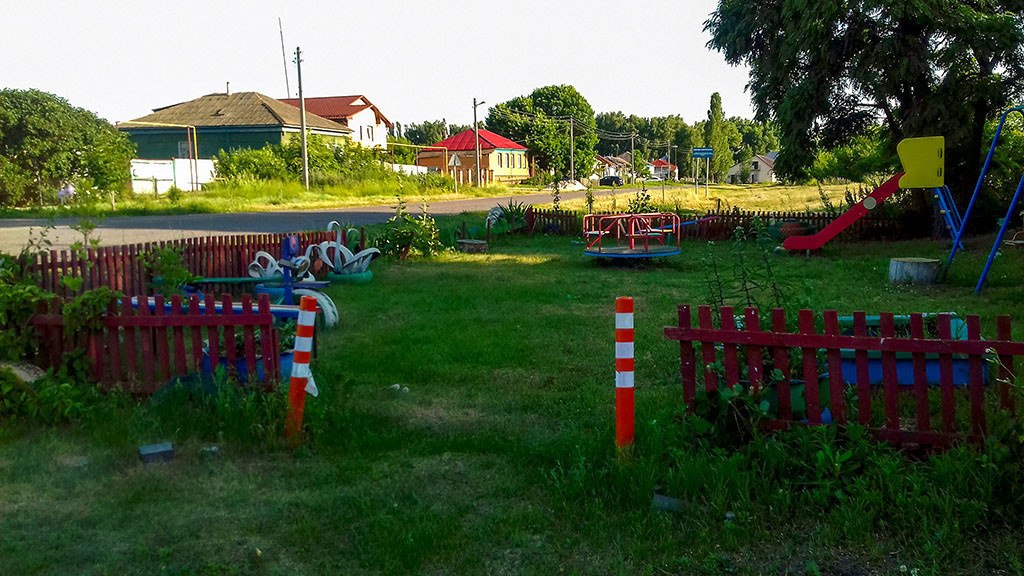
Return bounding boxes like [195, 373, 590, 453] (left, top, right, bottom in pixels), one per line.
[126, 92, 352, 133]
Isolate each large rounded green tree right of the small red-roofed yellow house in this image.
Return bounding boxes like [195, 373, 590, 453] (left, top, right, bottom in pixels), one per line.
[487, 85, 598, 177]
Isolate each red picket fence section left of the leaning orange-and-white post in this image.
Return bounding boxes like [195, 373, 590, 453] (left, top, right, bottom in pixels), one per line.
[32, 294, 281, 394]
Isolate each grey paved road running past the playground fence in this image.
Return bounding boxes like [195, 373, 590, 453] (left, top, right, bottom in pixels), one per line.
[0, 184, 635, 252]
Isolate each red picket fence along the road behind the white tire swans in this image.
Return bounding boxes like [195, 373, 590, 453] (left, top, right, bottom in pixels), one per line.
[32, 229, 367, 297]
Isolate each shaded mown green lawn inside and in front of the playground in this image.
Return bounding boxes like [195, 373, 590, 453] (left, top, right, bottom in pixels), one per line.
[0, 230, 1024, 575]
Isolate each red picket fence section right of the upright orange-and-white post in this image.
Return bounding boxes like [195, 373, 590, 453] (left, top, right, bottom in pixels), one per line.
[665, 305, 1024, 446]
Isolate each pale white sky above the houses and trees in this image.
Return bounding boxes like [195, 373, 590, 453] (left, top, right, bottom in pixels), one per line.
[0, 0, 753, 124]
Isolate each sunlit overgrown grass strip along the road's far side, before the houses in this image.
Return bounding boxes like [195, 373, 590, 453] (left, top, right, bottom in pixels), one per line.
[0, 178, 510, 217]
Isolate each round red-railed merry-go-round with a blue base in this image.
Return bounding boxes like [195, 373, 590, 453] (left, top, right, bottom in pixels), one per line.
[583, 212, 682, 259]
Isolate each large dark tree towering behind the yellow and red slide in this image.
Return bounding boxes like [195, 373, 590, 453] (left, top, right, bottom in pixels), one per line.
[705, 0, 1024, 194]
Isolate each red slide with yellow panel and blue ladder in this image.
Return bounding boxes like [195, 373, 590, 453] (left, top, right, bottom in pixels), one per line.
[782, 136, 946, 251]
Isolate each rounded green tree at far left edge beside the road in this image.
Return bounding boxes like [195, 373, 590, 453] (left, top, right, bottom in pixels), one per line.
[0, 89, 135, 206]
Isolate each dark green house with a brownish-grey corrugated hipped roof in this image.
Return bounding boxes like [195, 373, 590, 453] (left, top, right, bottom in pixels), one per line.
[118, 92, 352, 160]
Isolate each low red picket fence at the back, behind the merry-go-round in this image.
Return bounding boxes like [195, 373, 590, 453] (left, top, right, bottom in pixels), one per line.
[526, 207, 911, 242]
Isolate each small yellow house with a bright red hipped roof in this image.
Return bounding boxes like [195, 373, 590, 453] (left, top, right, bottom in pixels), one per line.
[416, 129, 529, 183]
